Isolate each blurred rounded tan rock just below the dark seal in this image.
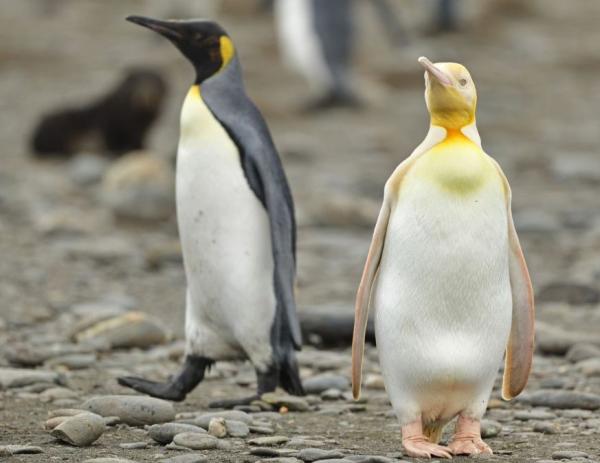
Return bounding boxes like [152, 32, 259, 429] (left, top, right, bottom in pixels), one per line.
[102, 151, 175, 220]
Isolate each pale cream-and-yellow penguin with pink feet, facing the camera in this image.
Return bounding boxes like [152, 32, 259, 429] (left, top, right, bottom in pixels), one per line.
[352, 57, 534, 458]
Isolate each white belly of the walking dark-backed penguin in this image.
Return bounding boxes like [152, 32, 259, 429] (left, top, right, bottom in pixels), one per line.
[177, 91, 275, 366]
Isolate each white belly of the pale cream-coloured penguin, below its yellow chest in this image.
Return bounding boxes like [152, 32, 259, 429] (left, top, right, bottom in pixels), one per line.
[373, 182, 512, 422]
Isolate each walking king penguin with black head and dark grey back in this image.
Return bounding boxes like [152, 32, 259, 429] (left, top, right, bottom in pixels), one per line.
[119, 16, 304, 408]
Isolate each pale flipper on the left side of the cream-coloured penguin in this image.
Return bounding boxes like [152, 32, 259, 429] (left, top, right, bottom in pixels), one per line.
[352, 199, 390, 399]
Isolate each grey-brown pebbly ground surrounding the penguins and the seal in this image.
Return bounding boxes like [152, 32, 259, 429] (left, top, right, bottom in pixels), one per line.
[0, 0, 600, 463]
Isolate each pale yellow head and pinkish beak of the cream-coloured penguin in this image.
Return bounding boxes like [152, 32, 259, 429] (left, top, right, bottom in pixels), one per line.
[419, 56, 477, 129]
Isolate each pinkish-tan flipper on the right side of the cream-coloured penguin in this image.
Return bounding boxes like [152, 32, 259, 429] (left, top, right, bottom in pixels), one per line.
[494, 161, 535, 400]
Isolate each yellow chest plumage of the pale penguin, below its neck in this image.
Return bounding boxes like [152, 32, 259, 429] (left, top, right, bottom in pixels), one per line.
[406, 130, 500, 196]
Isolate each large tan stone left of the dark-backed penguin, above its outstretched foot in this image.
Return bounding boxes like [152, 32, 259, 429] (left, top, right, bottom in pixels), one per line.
[74, 312, 170, 349]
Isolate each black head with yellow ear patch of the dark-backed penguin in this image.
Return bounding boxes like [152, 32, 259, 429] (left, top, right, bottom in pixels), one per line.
[127, 16, 235, 84]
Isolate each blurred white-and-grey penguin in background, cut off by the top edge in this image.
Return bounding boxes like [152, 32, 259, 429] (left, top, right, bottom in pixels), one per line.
[275, 0, 359, 110]
